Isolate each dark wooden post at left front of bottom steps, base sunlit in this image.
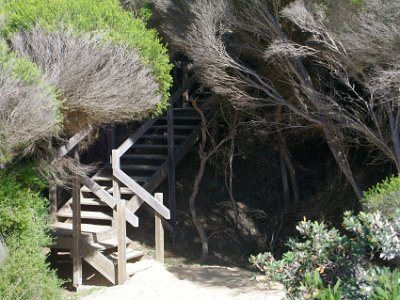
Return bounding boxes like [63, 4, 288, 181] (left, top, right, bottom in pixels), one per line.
[72, 149, 82, 288]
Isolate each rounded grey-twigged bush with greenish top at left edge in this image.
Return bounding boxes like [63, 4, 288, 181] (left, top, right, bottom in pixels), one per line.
[0, 40, 62, 164]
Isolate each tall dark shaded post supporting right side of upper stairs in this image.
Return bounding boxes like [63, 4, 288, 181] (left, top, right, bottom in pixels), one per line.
[167, 103, 176, 248]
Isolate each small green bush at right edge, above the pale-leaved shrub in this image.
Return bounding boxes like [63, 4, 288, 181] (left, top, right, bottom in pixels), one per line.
[361, 176, 400, 219]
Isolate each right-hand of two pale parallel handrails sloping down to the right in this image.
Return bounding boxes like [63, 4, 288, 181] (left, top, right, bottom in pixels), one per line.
[114, 168, 170, 219]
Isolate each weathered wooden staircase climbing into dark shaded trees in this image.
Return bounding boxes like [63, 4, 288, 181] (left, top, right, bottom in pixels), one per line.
[52, 82, 210, 285]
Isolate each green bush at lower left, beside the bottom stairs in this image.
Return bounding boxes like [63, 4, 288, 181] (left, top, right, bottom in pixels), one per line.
[0, 164, 60, 300]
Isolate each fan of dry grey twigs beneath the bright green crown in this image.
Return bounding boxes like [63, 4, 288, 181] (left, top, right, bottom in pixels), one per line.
[12, 28, 161, 134]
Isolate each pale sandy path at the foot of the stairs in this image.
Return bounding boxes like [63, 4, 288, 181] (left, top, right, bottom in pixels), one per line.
[81, 262, 285, 300]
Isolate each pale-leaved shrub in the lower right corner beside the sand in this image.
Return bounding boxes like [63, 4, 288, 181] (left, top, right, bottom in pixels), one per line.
[250, 211, 400, 299]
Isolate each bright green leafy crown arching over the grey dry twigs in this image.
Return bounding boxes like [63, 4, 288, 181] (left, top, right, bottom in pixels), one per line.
[0, 0, 172, 113]
